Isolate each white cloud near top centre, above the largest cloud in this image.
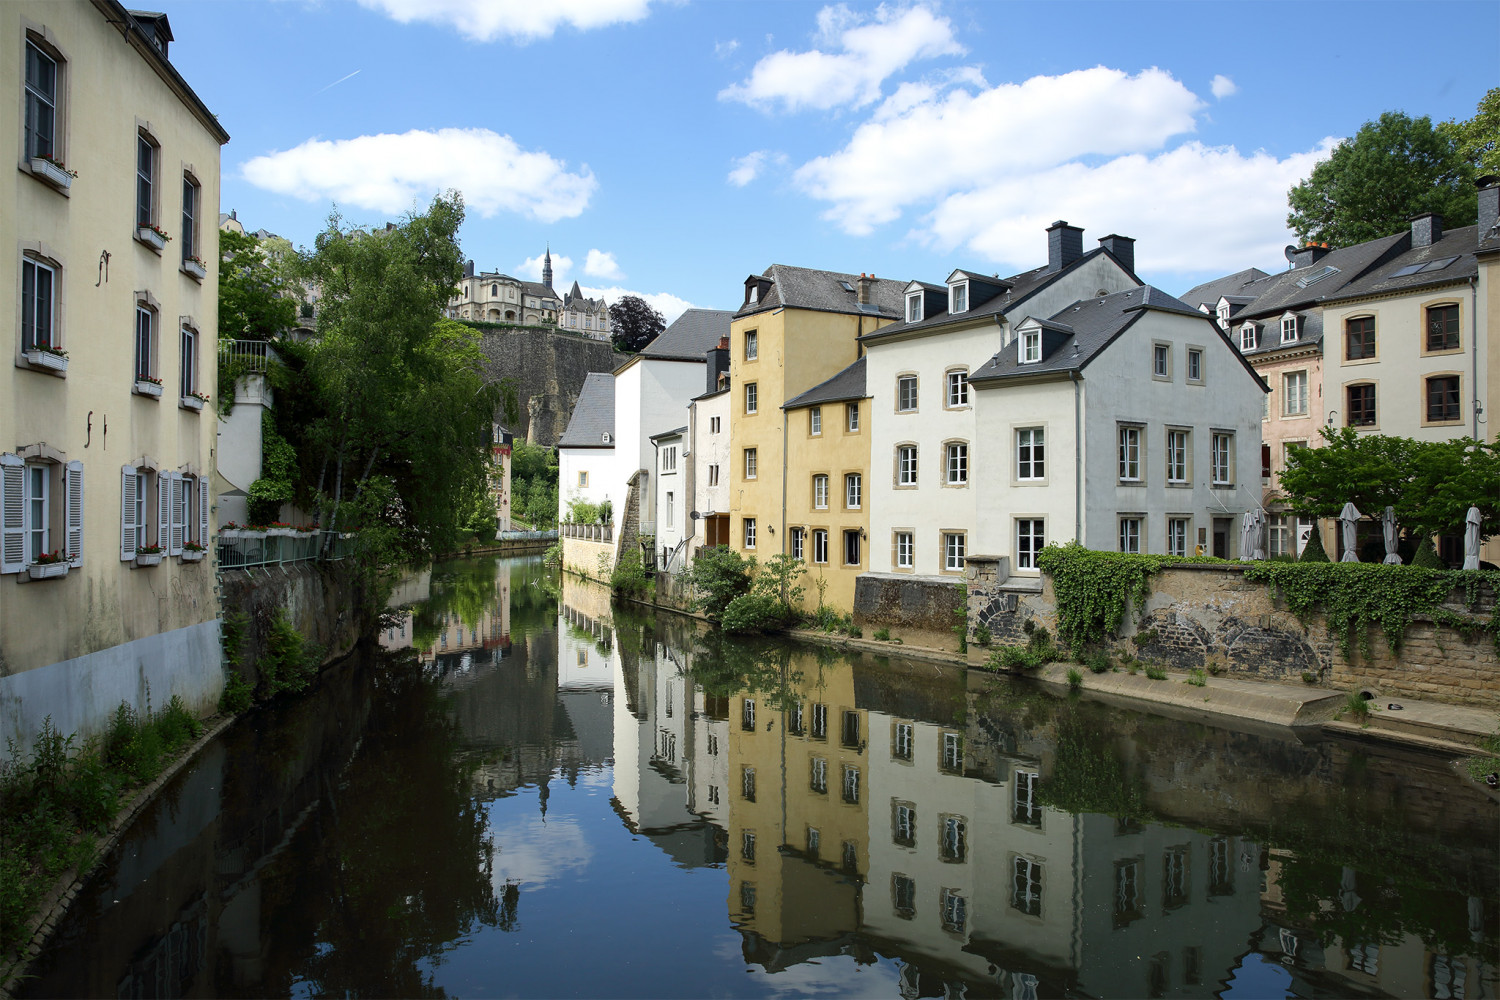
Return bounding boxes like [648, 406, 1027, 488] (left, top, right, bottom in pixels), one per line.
[719, 3, 965, 111]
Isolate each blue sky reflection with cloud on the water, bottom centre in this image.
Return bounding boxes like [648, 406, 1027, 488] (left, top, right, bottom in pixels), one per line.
[428, 772, 896, 997]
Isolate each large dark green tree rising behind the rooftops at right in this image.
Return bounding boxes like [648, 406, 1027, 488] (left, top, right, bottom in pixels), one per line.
[1287, 111, 1479, 247]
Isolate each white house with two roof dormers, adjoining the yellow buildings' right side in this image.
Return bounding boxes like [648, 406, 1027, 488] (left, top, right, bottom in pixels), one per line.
[861, 222, 1140, 579]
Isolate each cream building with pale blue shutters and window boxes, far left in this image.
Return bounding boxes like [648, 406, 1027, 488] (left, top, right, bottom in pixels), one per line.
[0, 0, 230, 745]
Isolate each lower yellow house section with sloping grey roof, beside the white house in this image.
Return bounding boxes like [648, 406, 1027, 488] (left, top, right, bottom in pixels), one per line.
[783, 358, 872, 612]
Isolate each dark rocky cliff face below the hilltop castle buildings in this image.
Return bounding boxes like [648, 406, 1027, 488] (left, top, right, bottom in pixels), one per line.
[468, 322, 629, 445]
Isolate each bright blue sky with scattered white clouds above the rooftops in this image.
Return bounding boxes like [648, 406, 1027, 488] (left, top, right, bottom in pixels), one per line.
[161, 0, 1500, 319]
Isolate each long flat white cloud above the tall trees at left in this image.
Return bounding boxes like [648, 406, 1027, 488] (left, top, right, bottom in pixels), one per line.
[242, 129, 599, 222]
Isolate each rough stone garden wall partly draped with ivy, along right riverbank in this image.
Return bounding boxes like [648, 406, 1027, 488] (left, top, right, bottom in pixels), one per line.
[969, 558, 1500, 709]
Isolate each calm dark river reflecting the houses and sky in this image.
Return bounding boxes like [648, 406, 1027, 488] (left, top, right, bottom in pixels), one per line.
[24, 559, 1500, 1000]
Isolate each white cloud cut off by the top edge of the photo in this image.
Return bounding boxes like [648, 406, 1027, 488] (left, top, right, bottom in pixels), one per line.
[359, 0, 650, 42]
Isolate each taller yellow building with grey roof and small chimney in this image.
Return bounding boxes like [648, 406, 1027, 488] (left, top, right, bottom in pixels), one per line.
[729, 264, 905, 607]
